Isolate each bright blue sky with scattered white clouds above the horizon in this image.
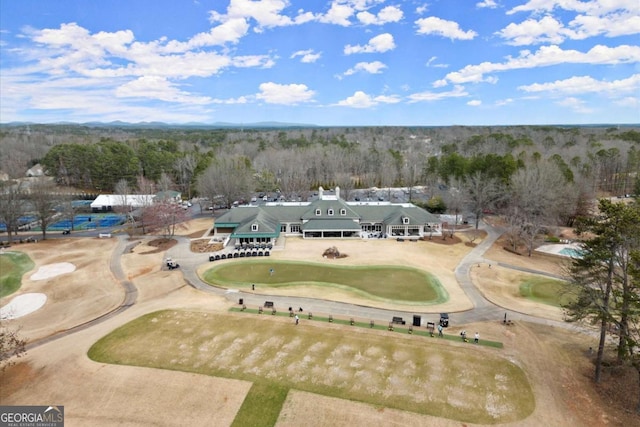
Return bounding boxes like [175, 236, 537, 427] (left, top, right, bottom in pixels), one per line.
[0, 0, 640, 126]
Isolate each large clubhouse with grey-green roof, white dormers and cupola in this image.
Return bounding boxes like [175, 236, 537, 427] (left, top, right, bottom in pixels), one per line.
[214, 187, 442, 245]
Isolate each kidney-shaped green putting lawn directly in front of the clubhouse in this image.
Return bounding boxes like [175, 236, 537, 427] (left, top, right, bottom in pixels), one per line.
[203, 259, 448, 304]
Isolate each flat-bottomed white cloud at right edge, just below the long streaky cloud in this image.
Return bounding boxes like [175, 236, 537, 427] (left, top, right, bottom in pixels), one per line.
[518, 74, 640, 97]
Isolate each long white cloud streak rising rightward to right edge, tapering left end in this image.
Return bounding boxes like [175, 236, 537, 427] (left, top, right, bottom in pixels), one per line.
[445, 45, 640, 83]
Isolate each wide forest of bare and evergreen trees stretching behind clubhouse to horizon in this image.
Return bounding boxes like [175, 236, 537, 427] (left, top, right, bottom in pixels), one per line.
[0, 124, 640, 246]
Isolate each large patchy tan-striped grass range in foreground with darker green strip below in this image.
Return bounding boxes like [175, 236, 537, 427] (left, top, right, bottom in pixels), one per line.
[89, 310, 535, 426]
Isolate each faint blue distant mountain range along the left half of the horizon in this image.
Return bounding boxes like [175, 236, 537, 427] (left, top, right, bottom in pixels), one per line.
[0, 120, 317, 129]
